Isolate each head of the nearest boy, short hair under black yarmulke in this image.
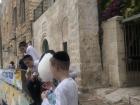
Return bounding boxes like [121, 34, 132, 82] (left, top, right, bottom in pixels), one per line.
[50, 51, 70, 70]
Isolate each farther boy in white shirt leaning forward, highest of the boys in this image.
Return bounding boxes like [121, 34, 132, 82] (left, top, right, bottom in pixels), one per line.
[19, 41, 40, 61]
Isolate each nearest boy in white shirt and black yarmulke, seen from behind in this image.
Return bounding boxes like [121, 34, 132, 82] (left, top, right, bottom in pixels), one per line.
[42, 51, 78, 105]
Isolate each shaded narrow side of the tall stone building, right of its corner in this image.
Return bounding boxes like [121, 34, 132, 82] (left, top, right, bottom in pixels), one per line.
[78, 0, 102, 92]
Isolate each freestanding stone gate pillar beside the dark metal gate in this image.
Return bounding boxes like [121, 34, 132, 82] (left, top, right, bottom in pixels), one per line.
[103, 17, 126, 87]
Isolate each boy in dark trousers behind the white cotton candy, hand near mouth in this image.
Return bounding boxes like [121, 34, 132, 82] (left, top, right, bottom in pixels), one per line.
[23, 55, 42, 105]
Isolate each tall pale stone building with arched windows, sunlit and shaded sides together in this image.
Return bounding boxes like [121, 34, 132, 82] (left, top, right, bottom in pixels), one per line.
[33, 0, 101, 91]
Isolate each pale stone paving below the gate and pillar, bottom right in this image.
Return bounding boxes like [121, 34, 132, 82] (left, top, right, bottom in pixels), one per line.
[80, 87, 140, 105]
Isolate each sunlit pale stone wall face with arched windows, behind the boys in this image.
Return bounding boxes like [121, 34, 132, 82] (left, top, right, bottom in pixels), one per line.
[33, 0, 80, 75]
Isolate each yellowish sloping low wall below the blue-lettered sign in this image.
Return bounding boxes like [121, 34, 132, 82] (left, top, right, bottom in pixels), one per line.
[0, 80, 30, 105]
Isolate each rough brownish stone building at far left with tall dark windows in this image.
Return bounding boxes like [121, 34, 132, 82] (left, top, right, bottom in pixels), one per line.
[1, 0, 41, 68]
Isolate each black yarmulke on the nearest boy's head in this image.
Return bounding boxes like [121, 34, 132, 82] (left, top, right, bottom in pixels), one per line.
[53, 51, 70, 62]
